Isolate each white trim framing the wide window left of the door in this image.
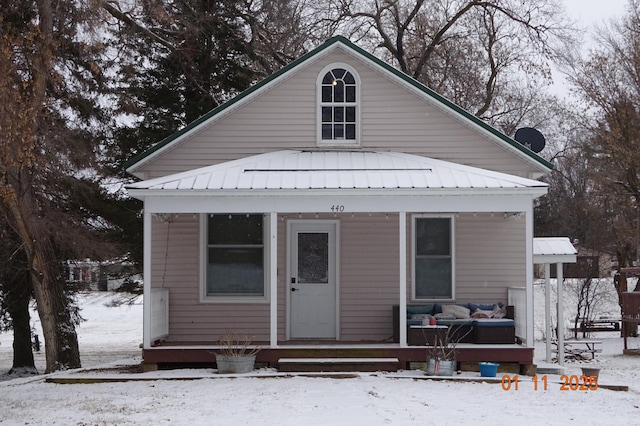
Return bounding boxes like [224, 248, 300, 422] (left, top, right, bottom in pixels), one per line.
[199, 213, 271, 303]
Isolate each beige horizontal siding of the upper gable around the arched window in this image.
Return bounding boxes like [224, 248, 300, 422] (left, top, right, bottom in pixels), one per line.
[140, 52, 533, 178]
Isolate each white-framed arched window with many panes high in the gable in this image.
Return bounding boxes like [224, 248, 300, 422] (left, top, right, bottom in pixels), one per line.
[318, 64, 360, 145]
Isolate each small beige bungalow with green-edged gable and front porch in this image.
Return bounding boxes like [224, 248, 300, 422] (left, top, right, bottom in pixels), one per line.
[127, 37, 552, 367]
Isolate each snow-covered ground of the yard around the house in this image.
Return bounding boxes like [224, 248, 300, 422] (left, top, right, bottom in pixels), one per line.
[0, 284, 640, 425]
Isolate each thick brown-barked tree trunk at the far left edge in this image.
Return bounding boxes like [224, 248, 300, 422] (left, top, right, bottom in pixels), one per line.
[0, 0, 80, 373]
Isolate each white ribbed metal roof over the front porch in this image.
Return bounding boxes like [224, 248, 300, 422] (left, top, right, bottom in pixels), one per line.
[127, 150, 547, 191]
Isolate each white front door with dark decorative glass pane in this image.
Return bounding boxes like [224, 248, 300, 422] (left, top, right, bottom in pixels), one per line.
[288, 221, 337, 339]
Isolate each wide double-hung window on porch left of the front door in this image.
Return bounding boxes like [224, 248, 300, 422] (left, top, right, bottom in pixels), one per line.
[204, 214, 267, 301]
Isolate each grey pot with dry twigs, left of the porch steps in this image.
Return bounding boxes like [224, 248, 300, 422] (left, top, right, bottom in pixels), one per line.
[216, 332, 260, 373]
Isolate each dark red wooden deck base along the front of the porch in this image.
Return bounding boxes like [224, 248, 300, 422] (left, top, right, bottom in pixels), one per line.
[142, 341, 534, 374]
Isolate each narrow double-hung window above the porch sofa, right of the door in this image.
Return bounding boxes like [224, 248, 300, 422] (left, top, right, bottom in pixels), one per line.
[413, 216, 454, 300]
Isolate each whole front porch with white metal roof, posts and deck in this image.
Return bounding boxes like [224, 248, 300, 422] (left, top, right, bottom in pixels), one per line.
[129, 151, 546, 368]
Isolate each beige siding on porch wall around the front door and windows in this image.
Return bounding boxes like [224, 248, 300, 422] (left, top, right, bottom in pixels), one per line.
[152, 213, 525, 343]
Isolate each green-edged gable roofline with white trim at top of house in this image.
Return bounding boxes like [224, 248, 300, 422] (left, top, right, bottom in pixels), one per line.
[125, 36, 553, 173]
